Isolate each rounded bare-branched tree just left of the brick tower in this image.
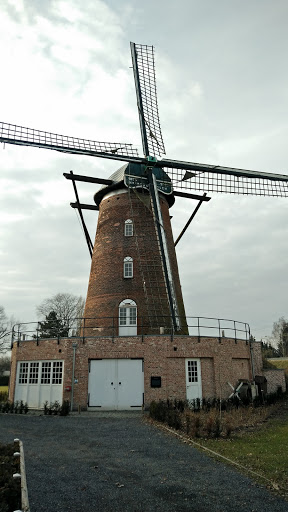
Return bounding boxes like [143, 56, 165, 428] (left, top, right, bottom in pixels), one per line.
[36, 293, 85, 330]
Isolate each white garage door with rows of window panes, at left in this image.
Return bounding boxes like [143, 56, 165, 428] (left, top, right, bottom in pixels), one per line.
[14, 361, 64, 409]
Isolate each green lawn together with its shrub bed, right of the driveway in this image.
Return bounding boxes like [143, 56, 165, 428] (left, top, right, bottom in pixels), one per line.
[149, 398, 288, 499]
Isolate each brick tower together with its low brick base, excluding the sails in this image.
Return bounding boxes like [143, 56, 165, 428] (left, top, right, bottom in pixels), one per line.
[10, 164, 284, 409]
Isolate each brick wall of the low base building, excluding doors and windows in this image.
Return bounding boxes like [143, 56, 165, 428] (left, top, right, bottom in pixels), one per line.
[10, 336, 252, 408]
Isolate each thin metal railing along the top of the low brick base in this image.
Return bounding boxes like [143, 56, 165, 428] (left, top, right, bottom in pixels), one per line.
[11, 316, 250, 346]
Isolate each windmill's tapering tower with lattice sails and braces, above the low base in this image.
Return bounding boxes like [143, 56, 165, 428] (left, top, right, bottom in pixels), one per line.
[0, 43, 288, 333]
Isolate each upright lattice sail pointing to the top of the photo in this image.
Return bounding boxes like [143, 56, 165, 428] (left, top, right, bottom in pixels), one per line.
[131, 43, 165, 156]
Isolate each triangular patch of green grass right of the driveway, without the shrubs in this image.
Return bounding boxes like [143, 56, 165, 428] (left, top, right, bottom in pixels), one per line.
[199, 414, 288, 496]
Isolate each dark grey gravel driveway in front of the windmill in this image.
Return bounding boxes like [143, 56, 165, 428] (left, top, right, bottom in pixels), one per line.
[0, 412, 288, 512]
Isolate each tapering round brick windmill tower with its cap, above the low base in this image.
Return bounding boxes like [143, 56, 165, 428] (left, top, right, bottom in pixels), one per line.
[84, 163, 188, 336]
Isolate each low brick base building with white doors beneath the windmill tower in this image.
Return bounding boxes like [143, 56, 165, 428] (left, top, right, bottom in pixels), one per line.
[10, 335, 258, 409]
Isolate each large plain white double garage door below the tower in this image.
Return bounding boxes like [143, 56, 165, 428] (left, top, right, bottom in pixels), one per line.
[88, 359, 144, 410]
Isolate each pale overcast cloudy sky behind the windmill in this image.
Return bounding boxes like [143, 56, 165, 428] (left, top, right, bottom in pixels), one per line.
[0, 0, 288, 339]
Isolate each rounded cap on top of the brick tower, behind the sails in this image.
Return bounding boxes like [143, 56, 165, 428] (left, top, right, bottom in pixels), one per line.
[94, 163, 175, 208]
